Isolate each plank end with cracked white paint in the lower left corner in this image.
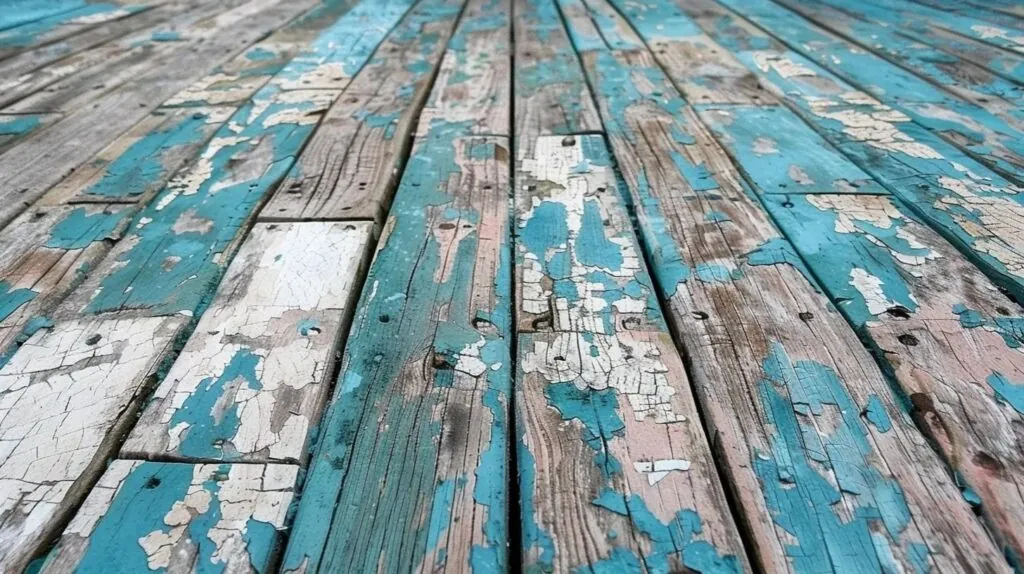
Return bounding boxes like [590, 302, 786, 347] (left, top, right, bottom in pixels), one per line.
[0, 317, 186, 572]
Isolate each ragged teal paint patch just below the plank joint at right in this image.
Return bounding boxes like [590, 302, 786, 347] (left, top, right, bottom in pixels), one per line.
[763, 195, 921, 328]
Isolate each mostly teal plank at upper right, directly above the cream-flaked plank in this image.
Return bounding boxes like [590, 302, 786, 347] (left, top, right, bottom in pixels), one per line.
[722, 0, 1024, 188]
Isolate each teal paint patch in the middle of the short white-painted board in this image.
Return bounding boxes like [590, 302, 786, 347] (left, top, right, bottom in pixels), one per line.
[169, 349, 263, 459]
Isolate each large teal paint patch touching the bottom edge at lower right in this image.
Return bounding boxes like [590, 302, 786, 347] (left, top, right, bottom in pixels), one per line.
[754, 343, 914, 572]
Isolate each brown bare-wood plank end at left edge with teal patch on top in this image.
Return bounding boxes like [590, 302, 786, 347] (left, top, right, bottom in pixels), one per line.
[0, 204, 130, 364]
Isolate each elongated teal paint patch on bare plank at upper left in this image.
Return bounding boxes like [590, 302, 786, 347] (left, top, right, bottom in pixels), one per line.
[85, 112, 221, 198]
